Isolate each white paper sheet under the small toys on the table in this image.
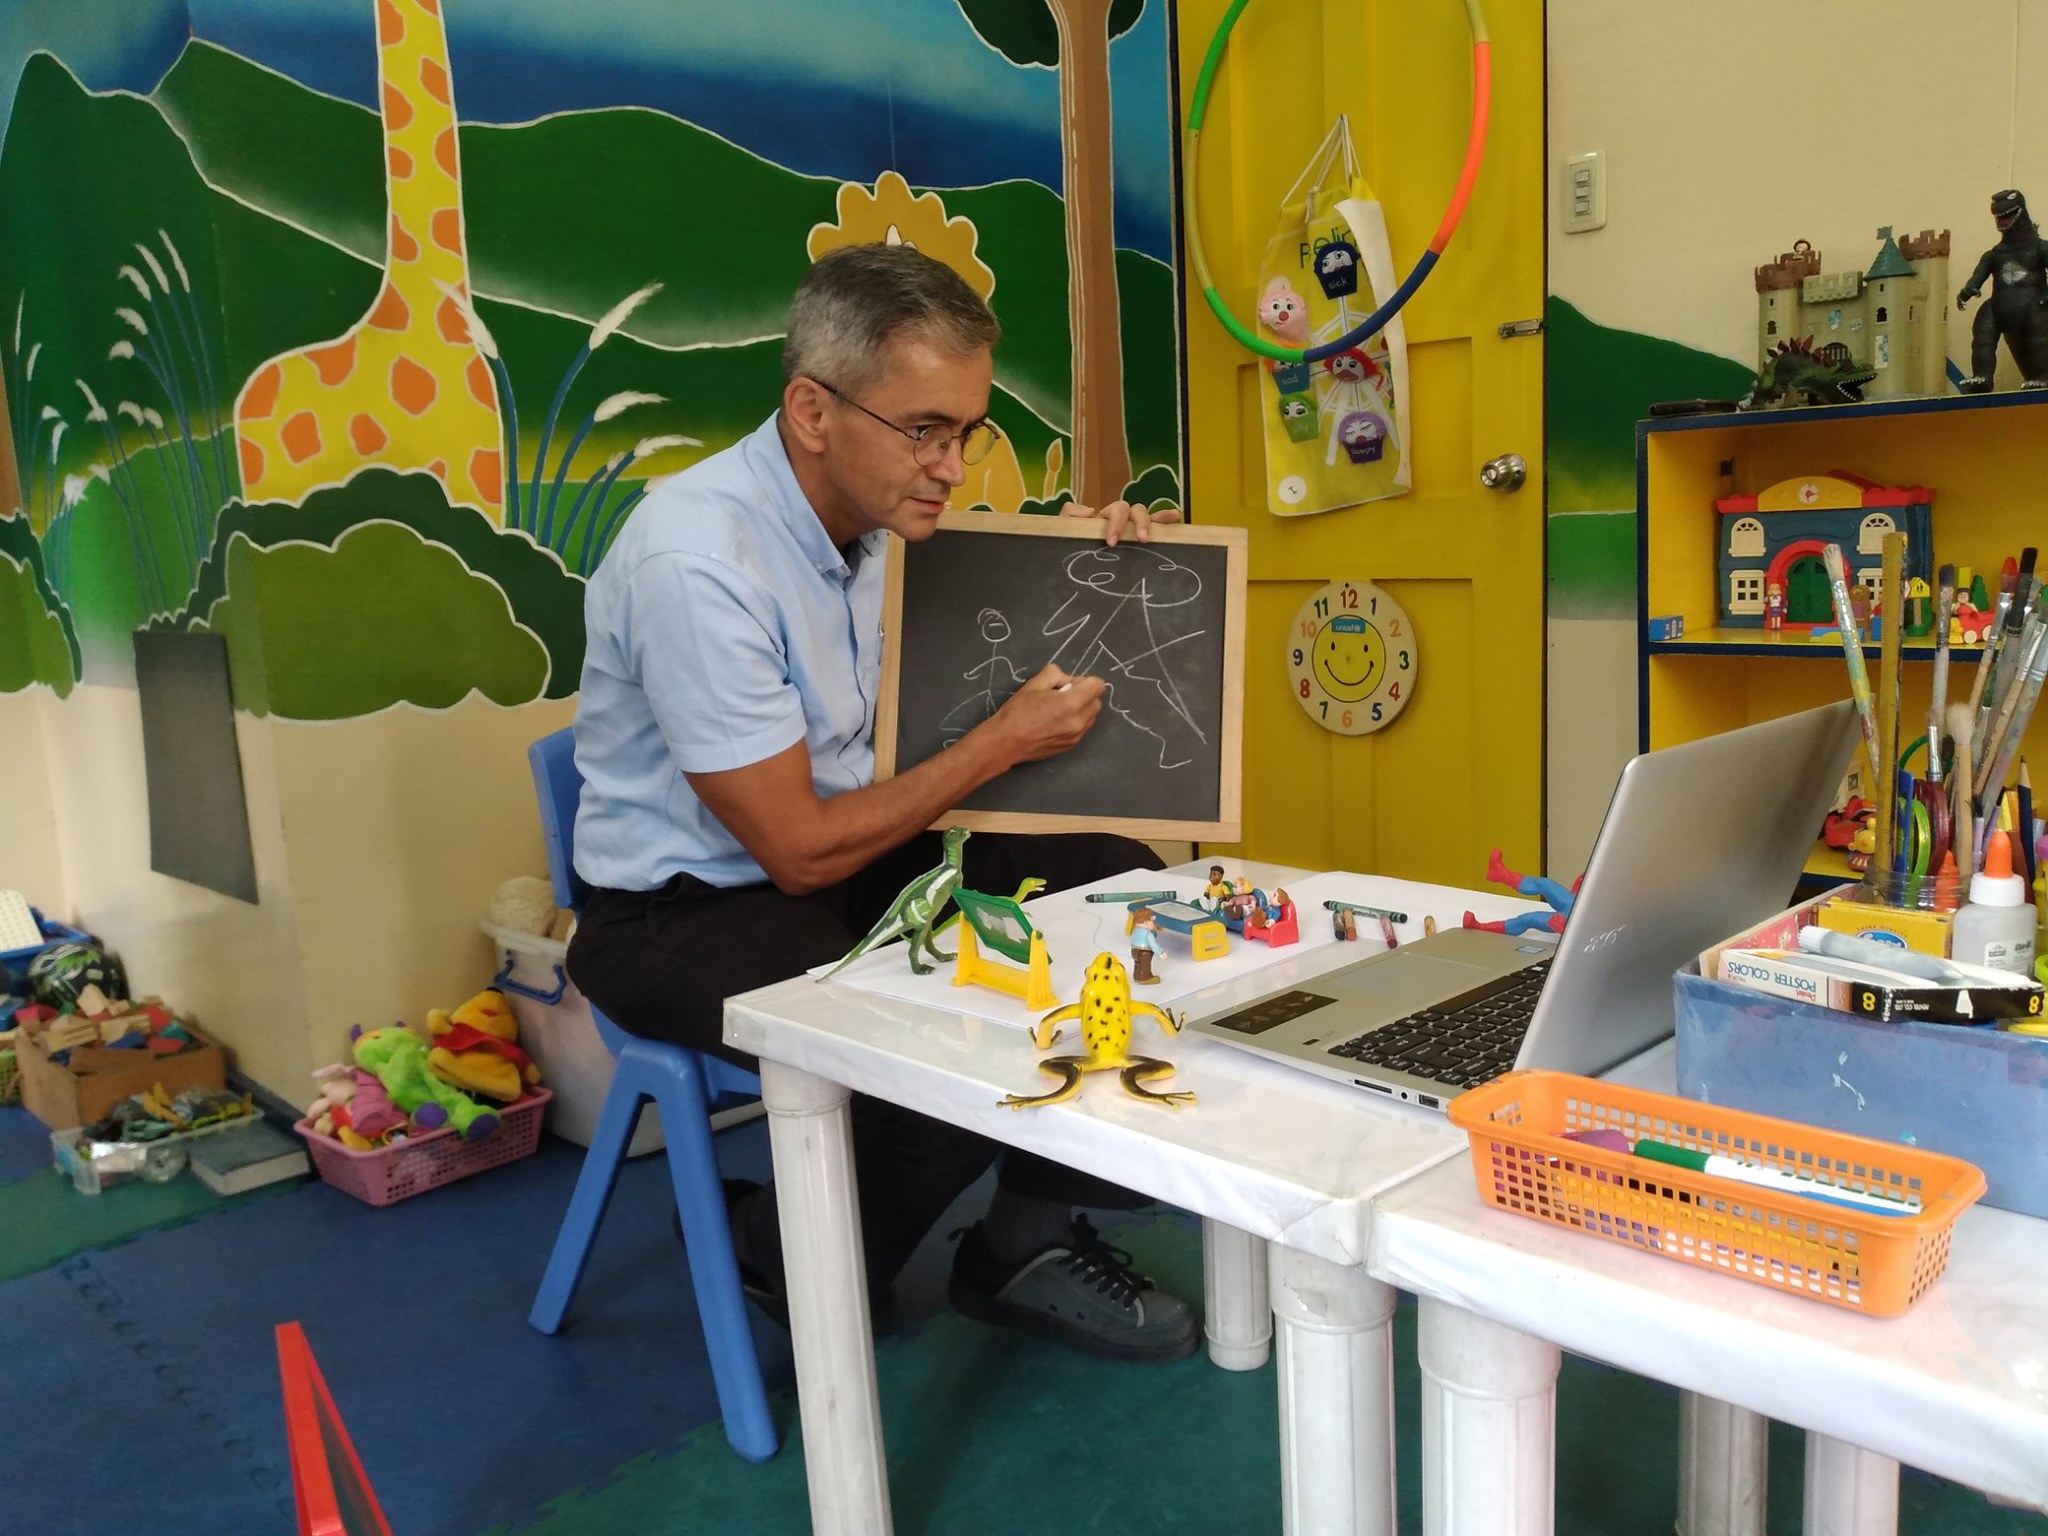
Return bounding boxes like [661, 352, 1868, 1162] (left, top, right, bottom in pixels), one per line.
[811, 870, 1528, 1030]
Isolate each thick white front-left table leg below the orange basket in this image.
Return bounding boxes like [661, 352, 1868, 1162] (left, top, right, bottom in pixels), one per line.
[1417, 1296, 1559, 1536]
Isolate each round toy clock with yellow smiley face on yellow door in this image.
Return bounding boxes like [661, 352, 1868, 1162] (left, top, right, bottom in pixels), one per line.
[1286, 582, 1419, 735]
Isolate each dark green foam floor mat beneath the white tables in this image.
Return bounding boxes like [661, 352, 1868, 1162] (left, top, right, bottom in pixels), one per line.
[494, 1221, 2048, 1536]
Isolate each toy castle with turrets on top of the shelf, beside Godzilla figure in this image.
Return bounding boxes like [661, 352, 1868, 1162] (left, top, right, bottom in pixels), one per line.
[1757, 225, 1952, 399]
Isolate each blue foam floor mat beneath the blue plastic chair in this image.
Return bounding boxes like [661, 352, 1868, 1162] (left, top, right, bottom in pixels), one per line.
[0, 1122, 793, 1536]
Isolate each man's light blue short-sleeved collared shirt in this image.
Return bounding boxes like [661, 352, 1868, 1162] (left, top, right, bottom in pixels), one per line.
[575, 416, 889, 891]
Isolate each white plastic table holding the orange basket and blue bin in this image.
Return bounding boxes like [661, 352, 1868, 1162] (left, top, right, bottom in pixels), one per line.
[1370, 1048, 2048, 1536]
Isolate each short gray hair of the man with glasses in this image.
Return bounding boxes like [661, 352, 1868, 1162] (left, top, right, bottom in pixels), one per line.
[782, 246, 1001, 395]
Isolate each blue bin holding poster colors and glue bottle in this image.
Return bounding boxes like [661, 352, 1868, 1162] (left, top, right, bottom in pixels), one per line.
[1673, 969, 2048, 1217]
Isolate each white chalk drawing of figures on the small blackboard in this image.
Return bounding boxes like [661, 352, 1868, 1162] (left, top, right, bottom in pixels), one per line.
[940, 545, 1208, 770]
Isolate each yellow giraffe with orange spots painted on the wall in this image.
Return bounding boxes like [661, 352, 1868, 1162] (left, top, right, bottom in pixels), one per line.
[236, 0, 506, 516]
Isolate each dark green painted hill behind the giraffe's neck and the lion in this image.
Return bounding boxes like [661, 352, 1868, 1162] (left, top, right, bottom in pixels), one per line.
[154, 41, 1180, 467]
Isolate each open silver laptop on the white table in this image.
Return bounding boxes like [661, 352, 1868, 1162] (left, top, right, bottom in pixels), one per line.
[1188, 700, 1858, 1108]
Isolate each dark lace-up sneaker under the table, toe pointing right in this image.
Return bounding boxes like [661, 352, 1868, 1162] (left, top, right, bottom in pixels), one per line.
[946, 1217, 1200, 1360]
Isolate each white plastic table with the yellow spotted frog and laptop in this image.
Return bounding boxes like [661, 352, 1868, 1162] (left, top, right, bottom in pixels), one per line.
[725, 860, 1528, 1536]
